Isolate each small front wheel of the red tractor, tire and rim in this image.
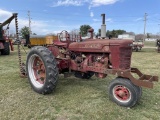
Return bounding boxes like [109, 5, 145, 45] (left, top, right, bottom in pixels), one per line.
[109, 78, 141, 107]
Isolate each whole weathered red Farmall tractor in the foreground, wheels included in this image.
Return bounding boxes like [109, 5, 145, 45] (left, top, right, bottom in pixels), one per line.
[26, 14, 158, 107]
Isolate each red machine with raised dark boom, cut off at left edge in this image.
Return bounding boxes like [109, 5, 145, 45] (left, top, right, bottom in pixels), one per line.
[0, 13, 17, 55]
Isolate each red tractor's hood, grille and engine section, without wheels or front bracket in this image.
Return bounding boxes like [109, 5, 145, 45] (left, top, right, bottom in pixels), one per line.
[48, 39, 132, 74]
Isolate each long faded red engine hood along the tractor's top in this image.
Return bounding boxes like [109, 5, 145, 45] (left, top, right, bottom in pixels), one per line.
[69, 39, 132, 52]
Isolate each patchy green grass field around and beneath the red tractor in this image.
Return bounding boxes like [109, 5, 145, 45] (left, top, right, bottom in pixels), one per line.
[0, 43, 160, 120]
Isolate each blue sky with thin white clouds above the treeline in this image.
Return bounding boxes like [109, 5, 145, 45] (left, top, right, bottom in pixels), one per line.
[0, 0, 160, 35]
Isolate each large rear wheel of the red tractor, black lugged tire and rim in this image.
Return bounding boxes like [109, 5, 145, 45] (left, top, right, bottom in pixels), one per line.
[26, 46, 58, 94]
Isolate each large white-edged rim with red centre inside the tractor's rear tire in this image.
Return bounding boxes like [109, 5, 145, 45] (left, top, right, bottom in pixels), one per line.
[28, 54, 46, 88]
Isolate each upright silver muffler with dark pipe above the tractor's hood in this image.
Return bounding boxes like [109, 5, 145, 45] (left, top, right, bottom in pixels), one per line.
[101, 14, 106, 39]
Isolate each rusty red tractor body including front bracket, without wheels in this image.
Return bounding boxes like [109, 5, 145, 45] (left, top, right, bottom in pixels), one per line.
[44, 31, 158, 88]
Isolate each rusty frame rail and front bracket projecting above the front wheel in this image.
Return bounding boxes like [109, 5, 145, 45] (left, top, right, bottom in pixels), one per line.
[75, 62, 158, 88]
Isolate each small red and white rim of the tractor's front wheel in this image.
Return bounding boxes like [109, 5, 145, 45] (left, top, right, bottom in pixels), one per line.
[113, 85, 131, 103]
